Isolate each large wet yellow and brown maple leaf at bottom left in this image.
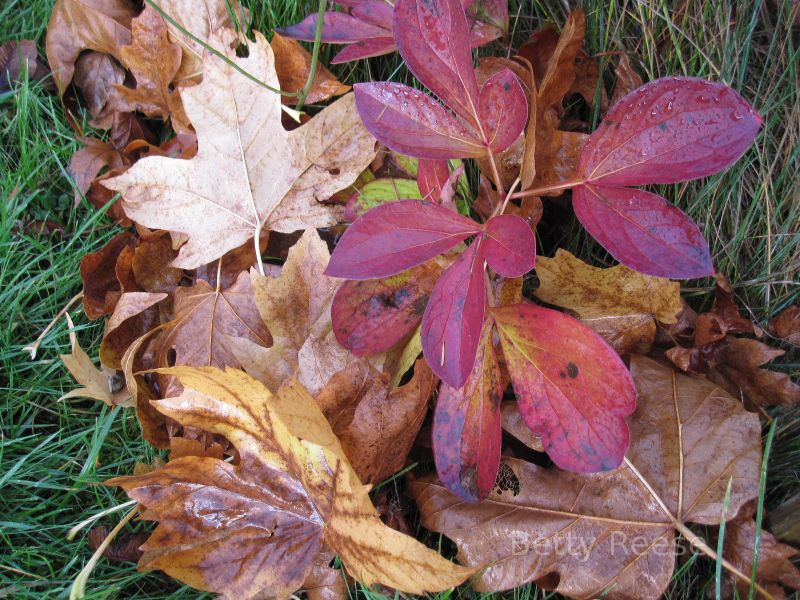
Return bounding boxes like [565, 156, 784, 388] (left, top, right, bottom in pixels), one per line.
[108, 367, 473, 599]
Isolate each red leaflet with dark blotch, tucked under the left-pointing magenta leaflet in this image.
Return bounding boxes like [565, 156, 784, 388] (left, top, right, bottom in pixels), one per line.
[331, 261, 442, 356]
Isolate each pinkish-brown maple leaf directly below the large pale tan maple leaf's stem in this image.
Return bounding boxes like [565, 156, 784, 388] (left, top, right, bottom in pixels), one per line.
[156, 271, 271, 368]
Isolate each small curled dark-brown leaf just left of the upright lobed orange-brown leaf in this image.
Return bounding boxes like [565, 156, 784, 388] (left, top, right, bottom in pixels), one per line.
[73, 51, 125, 129]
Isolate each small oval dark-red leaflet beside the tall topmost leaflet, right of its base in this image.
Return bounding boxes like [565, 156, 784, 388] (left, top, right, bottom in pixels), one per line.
[478, 69, 528, 152]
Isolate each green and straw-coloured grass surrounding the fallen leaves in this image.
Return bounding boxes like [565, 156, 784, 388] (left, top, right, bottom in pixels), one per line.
[0, 0, 800, 600]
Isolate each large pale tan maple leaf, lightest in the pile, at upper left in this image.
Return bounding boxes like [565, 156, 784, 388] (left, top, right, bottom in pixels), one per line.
[103, 31, 375, 269]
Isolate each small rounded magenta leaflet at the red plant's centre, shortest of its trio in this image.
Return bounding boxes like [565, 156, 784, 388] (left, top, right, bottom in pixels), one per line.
[483, 215, 536, 277]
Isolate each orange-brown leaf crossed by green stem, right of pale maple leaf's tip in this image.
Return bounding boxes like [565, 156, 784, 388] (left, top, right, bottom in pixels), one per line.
[269, 33, 350, 104]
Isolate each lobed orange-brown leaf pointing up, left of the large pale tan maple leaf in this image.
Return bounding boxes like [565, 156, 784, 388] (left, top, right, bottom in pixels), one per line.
[112, 4, 189, 133]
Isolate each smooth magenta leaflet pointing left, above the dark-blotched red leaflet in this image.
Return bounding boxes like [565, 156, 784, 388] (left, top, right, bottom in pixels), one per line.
[325, 200, 480, 279]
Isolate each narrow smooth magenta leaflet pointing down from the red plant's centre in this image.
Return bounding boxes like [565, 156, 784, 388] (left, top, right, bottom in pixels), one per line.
[422, 241, 486, 388]
